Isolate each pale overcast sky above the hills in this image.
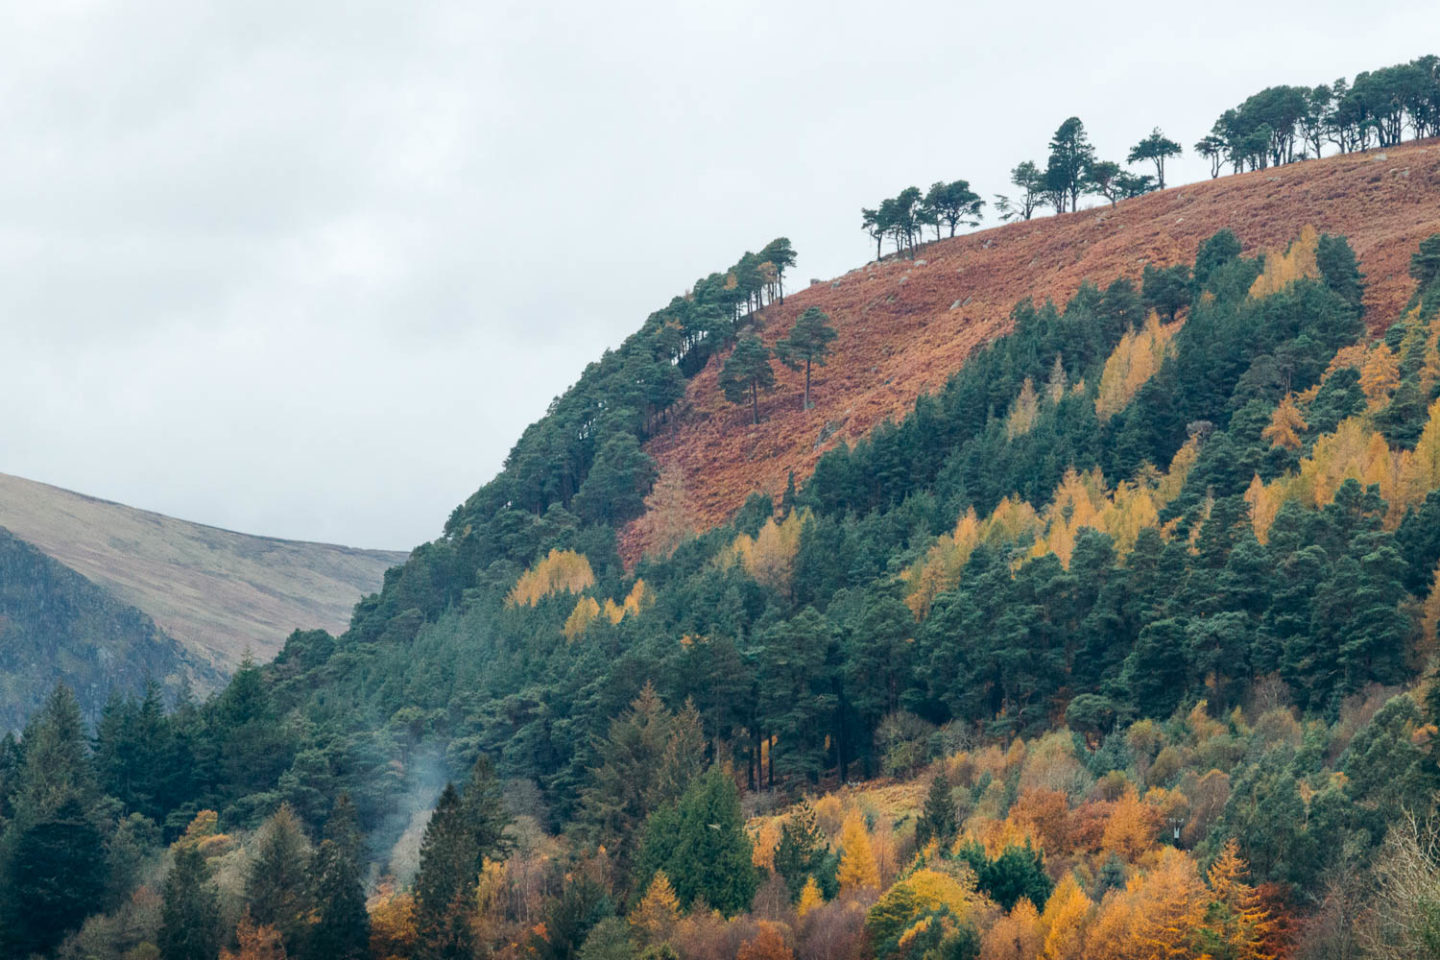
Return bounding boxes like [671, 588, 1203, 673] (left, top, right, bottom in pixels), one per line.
[0, 0, 1440, 548]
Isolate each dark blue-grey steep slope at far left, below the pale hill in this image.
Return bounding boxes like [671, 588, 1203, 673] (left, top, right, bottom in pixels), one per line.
[0, 528, 220, 731]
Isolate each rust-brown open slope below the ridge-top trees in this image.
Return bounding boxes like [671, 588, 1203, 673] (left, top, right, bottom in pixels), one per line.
[622, 140, 1440, 561]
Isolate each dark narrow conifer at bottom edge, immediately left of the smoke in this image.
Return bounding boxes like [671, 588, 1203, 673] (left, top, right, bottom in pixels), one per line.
[305, 793, 370, 960]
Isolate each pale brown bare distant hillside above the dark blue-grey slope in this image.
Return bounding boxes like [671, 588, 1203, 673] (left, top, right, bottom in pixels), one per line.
[0, 474, 405, 676]
